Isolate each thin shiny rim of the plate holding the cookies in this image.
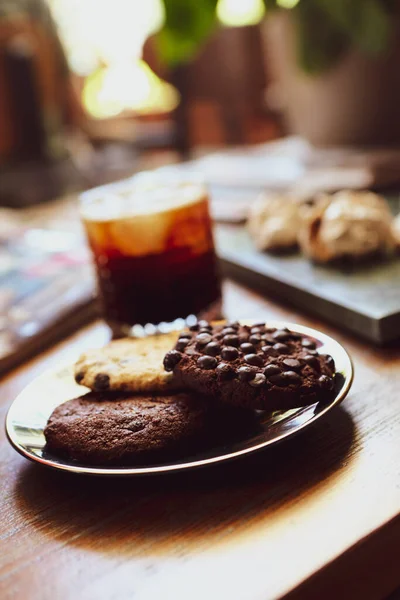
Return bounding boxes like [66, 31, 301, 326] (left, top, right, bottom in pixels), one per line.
[5, 319, 354, 477]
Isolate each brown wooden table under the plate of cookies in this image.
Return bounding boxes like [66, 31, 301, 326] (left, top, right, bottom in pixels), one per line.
[0, 282, 400, 600]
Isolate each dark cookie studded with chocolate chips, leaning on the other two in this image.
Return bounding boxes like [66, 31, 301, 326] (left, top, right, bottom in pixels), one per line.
[164, 321, 335, 410]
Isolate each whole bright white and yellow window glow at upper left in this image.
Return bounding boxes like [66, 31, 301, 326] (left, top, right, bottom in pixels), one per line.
[47, 0, 179, 119]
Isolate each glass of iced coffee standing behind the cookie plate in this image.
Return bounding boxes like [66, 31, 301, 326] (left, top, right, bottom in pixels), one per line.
[81, 173, 221, 337]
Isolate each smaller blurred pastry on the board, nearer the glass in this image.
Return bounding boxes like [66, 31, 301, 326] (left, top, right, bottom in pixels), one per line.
[247, 194, 306, 251]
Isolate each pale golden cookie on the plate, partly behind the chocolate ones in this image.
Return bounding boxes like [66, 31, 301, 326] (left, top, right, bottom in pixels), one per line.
[75, 332, 178, 393]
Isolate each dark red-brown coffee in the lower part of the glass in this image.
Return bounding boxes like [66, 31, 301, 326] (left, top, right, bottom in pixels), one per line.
[96, 247, 221, 326]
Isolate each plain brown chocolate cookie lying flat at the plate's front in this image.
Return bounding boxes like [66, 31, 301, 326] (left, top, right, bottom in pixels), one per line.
[44, 392, 208, 465]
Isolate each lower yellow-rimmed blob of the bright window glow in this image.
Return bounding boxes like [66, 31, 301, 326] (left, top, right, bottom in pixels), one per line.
[82, 59, 179, 119]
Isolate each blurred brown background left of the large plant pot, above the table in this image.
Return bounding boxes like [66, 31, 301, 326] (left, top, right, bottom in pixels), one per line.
[0, 0, 279, 206]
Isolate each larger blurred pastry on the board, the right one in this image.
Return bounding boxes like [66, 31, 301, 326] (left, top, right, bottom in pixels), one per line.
[298, 191, 395, 262]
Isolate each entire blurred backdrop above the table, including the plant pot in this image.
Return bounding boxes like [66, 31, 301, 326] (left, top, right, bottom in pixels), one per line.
[0, 0, 400, 206]
